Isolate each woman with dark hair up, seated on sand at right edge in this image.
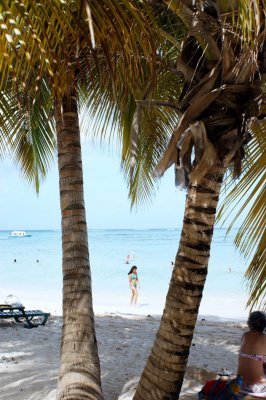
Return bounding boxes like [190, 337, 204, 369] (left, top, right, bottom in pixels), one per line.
[237, 311, 266, 393]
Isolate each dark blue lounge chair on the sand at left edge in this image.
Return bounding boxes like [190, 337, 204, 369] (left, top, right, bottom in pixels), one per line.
[0, 304, 50, 328]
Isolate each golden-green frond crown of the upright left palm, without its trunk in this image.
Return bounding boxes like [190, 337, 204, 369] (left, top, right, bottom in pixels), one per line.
[0, 0, 170, 192]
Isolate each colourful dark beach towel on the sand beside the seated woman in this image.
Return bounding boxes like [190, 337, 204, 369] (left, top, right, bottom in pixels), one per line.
[199, 376, 243, 400]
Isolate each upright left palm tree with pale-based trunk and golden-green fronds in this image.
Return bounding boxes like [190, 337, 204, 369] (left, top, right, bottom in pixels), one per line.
[0, 0, 161, 400]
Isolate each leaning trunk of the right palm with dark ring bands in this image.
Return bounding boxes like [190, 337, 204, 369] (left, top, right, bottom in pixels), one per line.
[134, 162, 224, 400]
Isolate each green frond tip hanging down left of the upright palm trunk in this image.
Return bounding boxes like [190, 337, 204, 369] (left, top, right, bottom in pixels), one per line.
[0, 77, 56, 192]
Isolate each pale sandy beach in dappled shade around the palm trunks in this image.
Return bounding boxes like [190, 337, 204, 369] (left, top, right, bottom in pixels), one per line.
[0, 314, 245, 400]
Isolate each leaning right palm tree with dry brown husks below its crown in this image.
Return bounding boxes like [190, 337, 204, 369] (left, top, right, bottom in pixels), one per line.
[116, 0, 266, 400]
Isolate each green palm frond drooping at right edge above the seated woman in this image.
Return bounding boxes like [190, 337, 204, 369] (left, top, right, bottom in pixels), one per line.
[218, 121, 266, 307]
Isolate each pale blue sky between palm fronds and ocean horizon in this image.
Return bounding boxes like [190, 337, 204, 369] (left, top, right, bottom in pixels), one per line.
[0, 143, 185, 230]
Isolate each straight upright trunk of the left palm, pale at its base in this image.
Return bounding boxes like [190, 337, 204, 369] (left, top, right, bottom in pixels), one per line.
[56, 90, 103, 400]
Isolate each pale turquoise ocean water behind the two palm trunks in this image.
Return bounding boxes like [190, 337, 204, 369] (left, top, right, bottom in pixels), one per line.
[0, 228, 248, 320]
